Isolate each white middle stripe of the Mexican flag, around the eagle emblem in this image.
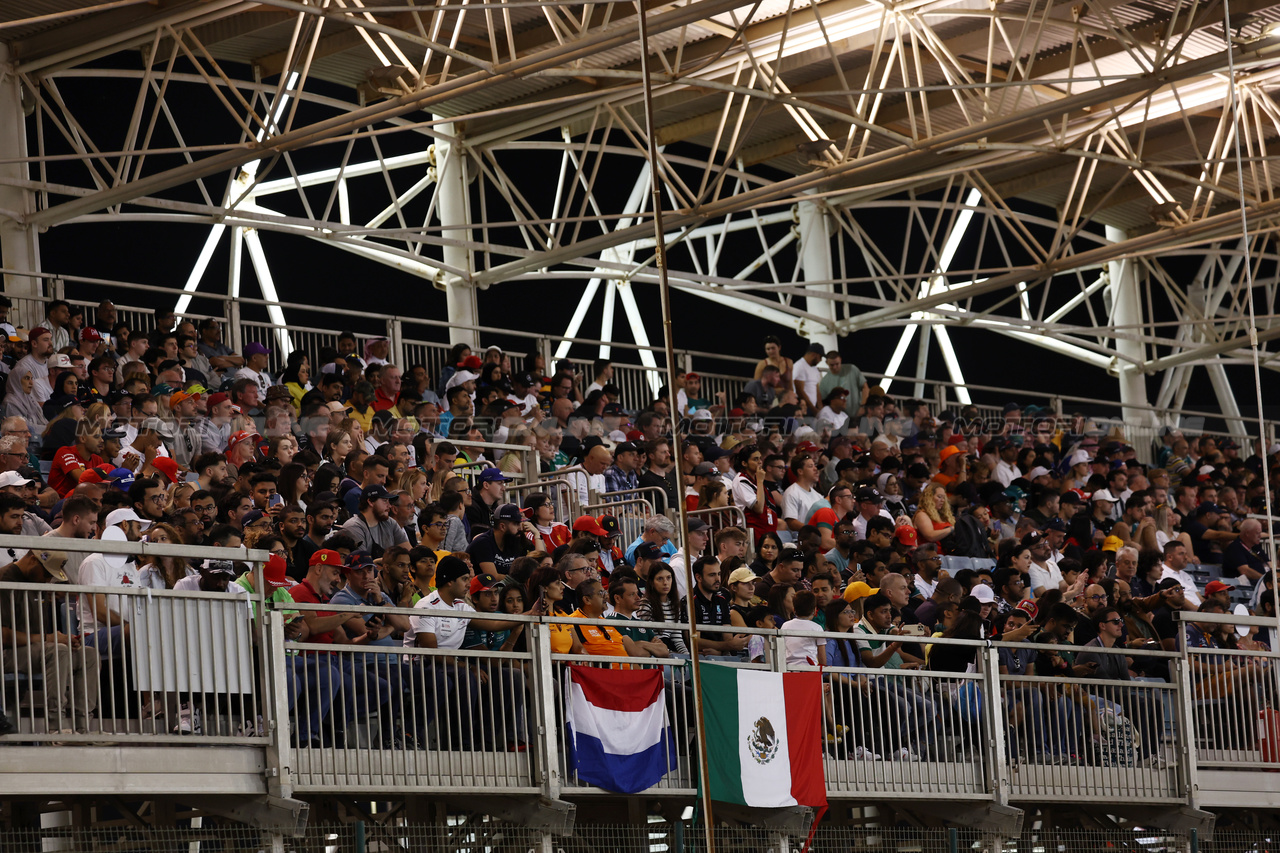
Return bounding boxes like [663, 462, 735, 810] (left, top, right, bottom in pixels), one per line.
[737, 670, 796, 808]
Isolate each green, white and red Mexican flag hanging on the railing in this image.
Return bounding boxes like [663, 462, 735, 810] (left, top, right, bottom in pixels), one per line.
[700, 663, 827, 808]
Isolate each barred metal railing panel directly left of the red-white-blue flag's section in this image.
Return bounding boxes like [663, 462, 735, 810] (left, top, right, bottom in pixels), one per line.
[288, 637, 540, 794]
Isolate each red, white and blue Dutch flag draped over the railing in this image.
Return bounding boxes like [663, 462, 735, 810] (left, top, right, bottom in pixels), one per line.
[564, 666, 676, 794]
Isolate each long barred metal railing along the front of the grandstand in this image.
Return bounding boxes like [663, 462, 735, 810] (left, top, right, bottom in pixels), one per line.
[0, 537, 1280, 819]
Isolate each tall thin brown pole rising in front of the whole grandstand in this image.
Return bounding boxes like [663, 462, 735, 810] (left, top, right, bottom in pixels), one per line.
[636, 0, 716, 853]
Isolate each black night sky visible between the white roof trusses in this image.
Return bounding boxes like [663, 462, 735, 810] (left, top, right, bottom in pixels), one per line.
[28, 49, 1276, 427]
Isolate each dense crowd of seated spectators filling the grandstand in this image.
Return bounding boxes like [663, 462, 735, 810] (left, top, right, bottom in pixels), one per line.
[0, 301, 1280, 761]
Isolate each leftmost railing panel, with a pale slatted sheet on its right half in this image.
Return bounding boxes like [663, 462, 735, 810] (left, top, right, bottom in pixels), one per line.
[0, 584, 271, 745]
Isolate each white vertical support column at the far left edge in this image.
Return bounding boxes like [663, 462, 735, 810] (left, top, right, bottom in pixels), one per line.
[0, 44, 44, 298]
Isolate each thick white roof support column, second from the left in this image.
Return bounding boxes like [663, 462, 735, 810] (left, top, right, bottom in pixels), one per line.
[435, 117, 480, 347]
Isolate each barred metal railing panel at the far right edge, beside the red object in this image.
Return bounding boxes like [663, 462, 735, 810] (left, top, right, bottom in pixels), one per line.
[1187, 637, 1280, 772]
